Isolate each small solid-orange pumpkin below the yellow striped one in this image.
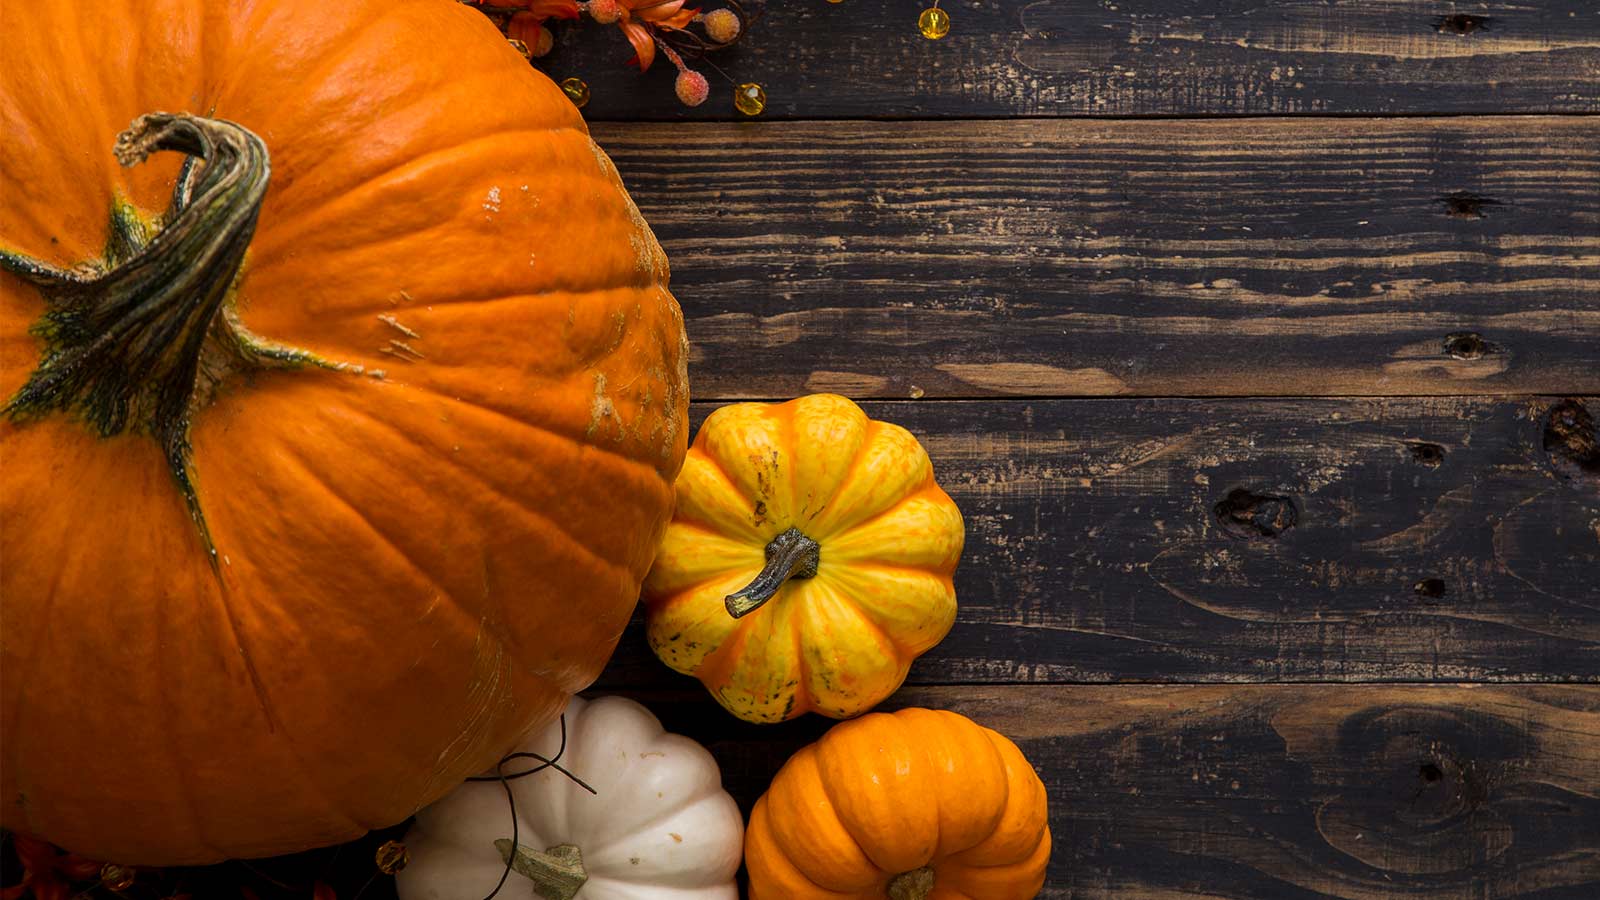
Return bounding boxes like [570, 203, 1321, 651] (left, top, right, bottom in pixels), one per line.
[744, 709, 1050, 900]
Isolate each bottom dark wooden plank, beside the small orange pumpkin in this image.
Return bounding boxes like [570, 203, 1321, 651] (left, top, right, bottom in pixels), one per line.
[614, 685, 1600, 900]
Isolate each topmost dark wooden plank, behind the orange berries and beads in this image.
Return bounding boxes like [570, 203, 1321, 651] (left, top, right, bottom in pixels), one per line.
[539, 0, 1600, 120]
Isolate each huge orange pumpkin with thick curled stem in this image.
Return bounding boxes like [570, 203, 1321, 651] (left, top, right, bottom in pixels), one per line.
[0, 0, 688, 863]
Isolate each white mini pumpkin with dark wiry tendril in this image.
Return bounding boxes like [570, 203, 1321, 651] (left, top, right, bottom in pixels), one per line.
[395, 697, 744, 900]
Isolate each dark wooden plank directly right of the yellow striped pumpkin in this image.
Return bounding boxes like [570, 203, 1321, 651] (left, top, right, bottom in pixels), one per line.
[603, 399, 1600, 687]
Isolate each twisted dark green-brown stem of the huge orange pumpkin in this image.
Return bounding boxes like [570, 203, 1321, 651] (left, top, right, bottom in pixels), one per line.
[0, 112, 374, 567]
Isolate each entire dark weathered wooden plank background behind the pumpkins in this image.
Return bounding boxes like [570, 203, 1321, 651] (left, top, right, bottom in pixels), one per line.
[21, 0, 1600, 900]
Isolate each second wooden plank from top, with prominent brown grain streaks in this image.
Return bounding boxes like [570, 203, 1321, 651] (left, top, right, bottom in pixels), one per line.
[594, 117, 1600, 399]
